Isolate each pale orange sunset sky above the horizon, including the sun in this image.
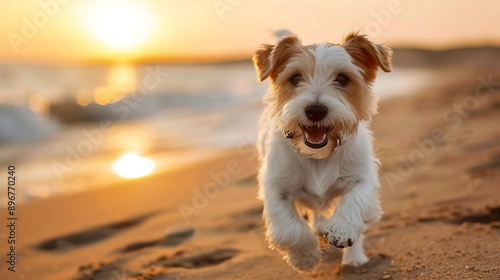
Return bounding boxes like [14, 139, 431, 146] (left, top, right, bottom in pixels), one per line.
[0, 0, 500, 62]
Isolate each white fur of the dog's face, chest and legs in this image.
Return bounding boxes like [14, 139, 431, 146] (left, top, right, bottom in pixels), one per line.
[258, 38, 382, 271]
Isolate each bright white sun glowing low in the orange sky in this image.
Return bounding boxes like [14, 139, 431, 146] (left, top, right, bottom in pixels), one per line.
[85, 1, 151, 49]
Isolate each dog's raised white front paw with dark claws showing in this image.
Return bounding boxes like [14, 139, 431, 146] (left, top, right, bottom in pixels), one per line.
[323, 220, 361, 248]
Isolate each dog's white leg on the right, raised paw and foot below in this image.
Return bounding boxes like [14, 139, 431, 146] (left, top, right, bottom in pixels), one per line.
[324, 184, 381, 265]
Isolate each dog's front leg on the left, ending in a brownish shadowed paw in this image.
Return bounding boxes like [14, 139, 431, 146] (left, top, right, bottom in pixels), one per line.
[264, 185, 321, 271]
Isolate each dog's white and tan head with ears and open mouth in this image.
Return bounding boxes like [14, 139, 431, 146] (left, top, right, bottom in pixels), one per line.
[253, 33, 392, 159]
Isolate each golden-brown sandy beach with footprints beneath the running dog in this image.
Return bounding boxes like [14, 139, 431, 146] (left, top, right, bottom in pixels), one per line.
[0, 51, 500, 280]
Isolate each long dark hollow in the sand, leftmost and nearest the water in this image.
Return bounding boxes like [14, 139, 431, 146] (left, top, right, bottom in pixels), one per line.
[34, 213, 156, 251]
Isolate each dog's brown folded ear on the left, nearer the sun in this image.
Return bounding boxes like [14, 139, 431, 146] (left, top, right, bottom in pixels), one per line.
[252, 35, 301, 82]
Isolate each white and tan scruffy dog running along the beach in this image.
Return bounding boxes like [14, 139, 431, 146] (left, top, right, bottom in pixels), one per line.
[252, 32, 392, 272]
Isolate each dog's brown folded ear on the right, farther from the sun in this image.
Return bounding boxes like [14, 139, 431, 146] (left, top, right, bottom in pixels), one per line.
[342, 32, 392, 83]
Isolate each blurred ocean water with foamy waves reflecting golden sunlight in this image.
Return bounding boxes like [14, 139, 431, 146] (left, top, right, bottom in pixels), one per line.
[0, 62, 431, 203]
